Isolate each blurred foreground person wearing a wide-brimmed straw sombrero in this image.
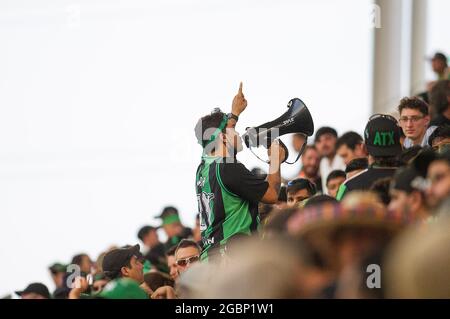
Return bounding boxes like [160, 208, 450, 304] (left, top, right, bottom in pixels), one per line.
[287, 192, 407, 298]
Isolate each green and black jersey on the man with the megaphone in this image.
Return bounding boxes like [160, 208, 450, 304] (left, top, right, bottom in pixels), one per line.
[196, 155, 269, 260]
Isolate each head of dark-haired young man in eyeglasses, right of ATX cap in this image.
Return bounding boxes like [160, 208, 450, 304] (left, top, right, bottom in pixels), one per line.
[398, 97, 437, 148]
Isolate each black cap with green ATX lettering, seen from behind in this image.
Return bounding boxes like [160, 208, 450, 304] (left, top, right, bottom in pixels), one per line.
[364, 114, 402, 157]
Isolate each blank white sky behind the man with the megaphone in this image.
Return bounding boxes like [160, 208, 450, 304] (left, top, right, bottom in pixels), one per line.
[0, 0, 450, 296]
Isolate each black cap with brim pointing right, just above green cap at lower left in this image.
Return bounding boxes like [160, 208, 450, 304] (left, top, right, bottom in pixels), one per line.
[102, 244, 142, 278]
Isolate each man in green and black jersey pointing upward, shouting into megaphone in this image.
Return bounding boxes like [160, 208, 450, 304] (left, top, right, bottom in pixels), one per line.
[195, 83, 286, 260]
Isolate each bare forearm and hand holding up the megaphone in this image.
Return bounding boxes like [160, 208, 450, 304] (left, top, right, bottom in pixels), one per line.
[261, 140, 286, 204]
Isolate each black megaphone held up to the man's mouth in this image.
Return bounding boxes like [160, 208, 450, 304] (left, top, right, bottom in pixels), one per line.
[242, 98, 314, 164]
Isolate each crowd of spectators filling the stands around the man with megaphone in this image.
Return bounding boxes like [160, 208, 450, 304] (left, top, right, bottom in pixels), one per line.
[8, 56, 450, 299]
